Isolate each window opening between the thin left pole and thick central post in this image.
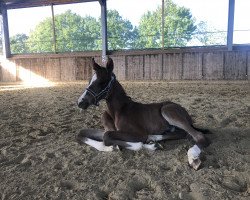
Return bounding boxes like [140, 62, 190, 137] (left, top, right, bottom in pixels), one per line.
[54, 2, 102, 52]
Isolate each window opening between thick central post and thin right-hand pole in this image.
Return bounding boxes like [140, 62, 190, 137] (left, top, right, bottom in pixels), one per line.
[107, 0, 162, 50]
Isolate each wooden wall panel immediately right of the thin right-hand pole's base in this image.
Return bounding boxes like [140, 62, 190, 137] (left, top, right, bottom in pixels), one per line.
[163, 53, 182, 80]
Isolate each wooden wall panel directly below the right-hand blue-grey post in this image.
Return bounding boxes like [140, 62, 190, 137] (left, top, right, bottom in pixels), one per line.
[224, 51, 247, 80]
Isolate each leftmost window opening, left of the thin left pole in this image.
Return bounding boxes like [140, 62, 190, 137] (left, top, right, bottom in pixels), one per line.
[8, 6, 53, 54]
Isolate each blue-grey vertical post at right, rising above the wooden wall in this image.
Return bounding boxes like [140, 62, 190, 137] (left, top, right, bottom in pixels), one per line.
[227, 0, 235, 51]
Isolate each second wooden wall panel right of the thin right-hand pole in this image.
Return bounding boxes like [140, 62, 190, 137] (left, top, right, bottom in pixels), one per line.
[182, 53, 202, 80]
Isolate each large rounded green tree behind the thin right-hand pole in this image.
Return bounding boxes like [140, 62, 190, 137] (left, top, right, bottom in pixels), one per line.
[137, 0, 197, 48]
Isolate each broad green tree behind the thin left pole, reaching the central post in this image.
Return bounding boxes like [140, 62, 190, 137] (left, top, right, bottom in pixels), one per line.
[28, 10, 101, 52]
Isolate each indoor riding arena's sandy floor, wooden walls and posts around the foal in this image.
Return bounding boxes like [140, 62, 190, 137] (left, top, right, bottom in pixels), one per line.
[0, 0, 250, 200]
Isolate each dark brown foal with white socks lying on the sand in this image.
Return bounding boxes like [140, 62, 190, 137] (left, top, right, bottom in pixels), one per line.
[77, 58, 210, 170]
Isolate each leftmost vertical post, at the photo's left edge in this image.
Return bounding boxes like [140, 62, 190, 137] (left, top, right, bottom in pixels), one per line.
[1, 1, 11, 58]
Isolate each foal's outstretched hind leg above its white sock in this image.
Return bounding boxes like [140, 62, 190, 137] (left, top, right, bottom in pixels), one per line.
[161, 103, 209, 147]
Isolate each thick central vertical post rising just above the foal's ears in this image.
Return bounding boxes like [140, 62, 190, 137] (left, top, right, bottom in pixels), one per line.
[99, 0, 108, 63]
